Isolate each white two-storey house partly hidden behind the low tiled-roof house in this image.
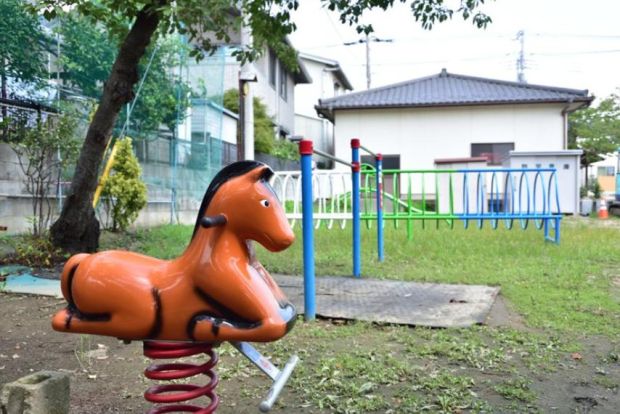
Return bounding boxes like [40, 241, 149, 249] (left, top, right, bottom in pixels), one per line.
[295, 53, 353, 160]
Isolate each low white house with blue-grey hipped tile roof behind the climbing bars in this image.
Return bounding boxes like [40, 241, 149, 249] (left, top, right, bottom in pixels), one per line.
[317, 69, 593, 213]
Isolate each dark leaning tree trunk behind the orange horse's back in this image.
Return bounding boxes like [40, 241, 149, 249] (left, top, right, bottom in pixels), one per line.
[51, 1, 164, 253]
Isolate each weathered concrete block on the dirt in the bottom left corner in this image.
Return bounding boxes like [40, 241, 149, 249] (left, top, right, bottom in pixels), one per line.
[0, 371, 69, 414]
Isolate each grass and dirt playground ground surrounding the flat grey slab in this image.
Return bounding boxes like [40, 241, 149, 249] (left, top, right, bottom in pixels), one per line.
[0, 220, 620, 413]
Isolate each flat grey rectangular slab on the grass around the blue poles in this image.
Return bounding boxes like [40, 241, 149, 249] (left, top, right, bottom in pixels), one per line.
[274, 275, 499, 328]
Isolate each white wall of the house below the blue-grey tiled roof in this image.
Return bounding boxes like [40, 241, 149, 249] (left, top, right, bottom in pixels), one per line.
[335, 104, 564, 169]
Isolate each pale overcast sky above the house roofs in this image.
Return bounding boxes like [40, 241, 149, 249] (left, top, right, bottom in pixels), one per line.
[291, 0, 620, 97]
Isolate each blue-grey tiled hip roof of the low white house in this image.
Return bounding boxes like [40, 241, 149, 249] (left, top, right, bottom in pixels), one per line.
[316, 69, 594, 121]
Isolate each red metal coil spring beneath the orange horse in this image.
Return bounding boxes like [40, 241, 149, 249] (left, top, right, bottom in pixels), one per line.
[144, 341, 220, 414]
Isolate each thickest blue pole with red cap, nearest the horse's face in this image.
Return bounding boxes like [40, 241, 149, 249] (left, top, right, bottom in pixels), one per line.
[299, 139, 316, 321]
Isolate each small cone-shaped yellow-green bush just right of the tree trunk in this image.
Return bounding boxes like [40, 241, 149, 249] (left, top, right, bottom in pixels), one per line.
[101, 138, 146, 231]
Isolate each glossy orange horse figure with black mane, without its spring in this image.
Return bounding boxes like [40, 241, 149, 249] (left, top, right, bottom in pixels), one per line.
[52, 161, 296, 412]
